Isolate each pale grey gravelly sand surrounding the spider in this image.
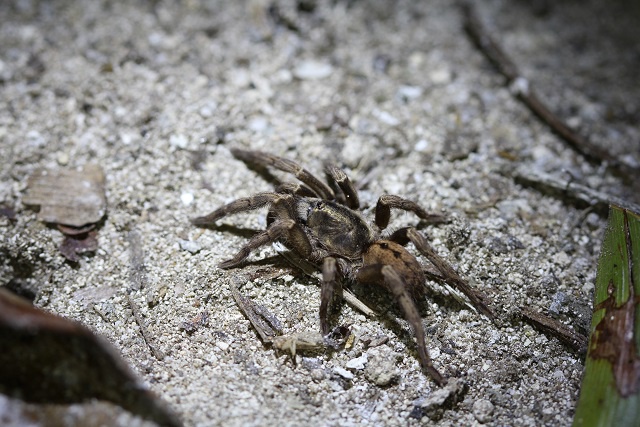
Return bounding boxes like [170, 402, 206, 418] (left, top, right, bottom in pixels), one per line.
[0, 0, 640, 426]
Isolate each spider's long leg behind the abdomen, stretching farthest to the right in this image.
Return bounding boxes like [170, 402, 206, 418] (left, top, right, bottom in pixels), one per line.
[389, 227, 496, 320]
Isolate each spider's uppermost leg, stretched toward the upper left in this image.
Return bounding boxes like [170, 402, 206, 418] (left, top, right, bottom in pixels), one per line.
[231, 148, 334, 200]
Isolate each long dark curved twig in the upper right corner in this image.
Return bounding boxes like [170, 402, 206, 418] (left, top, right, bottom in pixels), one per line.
[462, 2, 632, 174]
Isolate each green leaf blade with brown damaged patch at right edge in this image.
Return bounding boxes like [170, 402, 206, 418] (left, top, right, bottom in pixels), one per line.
[573, 206, 640, 426]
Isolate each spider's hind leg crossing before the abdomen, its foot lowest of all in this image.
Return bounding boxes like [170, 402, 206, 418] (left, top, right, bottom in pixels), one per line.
[357, 264, 447, 386]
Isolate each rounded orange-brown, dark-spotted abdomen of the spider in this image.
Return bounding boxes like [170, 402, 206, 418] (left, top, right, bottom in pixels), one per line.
[362, 240, 425, 297]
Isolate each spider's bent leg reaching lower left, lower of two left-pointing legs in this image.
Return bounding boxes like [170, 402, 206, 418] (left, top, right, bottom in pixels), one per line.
[218, 219, 311, 268]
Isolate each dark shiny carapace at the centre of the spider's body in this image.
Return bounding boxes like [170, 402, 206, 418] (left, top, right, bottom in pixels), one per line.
[298, 200, 374, 259]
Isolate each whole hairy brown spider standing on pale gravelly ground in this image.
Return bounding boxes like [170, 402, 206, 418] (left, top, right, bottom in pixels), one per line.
[192, 149, 490, 385]
